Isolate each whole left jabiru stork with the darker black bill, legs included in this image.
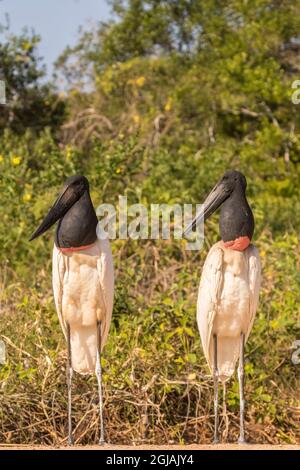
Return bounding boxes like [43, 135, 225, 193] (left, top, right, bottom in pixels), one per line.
[30, 175, 114, 445]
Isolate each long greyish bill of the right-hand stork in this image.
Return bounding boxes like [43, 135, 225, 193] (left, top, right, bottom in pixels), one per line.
[183, 181, 230, 237]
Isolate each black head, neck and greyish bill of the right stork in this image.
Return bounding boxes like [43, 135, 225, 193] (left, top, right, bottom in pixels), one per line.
[185, 170, 254, 246]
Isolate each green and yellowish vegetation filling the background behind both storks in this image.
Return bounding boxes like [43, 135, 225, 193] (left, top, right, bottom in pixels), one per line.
[0, 0, 300, 444]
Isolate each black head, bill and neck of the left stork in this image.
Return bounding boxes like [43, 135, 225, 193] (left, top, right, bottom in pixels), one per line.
[30, 175, 98, 247]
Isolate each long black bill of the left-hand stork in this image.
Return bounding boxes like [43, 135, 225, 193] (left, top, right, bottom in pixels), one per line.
[29, 187, 78, 241]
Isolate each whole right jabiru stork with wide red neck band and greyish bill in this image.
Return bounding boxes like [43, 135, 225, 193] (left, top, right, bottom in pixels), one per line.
[185, 170, 261, 444]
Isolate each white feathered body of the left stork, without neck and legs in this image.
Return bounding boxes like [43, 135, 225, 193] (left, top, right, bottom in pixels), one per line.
[53, 239, 114, 374]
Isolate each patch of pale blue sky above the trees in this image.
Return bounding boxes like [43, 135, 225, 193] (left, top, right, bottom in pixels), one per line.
[0, 0, 109, 75]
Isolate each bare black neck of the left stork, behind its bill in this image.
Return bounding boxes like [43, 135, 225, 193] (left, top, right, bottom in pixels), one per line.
[55, 191, 98, 248]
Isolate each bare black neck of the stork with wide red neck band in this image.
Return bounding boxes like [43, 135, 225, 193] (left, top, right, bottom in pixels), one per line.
[220, 184, 254, 242]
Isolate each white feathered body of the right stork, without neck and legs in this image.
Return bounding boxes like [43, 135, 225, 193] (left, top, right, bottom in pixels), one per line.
[197, 242, 261, 381]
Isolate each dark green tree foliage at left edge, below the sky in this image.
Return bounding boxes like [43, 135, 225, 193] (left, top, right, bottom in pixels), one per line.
[0, 25, 65, 134]
